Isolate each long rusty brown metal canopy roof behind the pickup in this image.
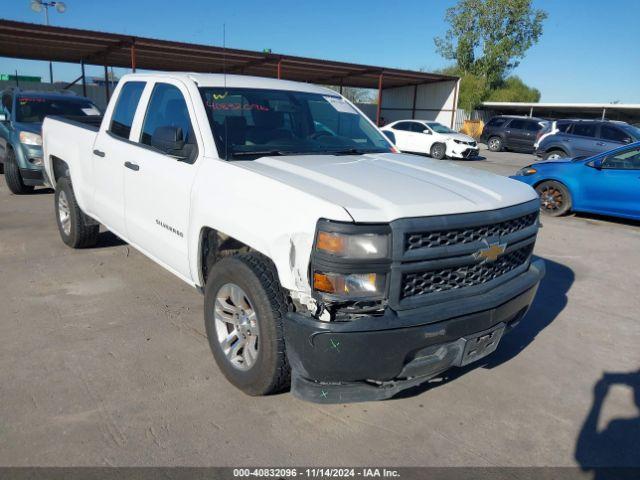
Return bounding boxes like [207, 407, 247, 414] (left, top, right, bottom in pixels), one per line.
[0, 20, 458, 88]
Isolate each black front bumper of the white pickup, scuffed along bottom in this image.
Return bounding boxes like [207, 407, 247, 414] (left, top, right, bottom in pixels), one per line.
[285, 260, 544, 403]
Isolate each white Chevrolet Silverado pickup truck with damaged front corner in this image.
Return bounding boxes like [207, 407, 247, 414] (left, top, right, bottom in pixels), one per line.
[43, 73, 544, 402]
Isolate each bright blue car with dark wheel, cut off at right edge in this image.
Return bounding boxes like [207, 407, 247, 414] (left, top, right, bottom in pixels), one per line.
[511, 142, 640, 220]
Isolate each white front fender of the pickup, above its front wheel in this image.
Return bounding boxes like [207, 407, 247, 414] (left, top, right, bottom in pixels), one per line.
[189, 158, 353, 293]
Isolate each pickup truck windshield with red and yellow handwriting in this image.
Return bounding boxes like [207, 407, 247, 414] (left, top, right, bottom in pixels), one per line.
[200, 87, 392, 160]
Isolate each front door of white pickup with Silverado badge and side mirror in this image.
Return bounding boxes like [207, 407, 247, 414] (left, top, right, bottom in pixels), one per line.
[124, 80, 202, 278]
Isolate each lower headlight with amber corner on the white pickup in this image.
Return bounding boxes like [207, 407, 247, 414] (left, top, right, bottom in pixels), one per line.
[313, 272, 386, 298]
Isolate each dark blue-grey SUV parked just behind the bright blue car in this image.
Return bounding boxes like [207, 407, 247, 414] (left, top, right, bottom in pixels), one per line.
[535, 120, 640, 160]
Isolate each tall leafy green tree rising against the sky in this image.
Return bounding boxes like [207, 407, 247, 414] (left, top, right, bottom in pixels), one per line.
[435, 0, 547, 89]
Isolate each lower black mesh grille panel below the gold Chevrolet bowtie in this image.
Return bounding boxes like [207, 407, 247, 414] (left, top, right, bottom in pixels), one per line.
[400, 243, 533, 299]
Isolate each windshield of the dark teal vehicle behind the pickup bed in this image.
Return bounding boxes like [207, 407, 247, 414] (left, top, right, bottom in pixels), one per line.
[16, 96, 100, 123]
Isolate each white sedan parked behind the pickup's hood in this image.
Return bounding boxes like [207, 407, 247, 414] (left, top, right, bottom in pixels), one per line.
[382, 120, 478, 160]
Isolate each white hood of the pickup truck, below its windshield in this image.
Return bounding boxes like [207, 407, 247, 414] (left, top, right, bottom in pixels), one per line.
[234, 153, 537, 222]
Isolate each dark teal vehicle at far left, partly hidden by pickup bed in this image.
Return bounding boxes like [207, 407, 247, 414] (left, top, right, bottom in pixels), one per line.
[0, 88, 100, 194]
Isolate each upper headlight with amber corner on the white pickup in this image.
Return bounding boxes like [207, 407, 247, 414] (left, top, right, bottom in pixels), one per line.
[316, 230, 389, 259]
